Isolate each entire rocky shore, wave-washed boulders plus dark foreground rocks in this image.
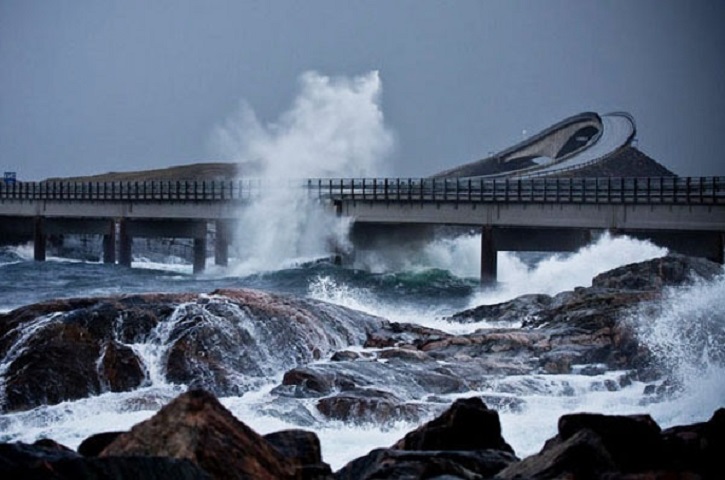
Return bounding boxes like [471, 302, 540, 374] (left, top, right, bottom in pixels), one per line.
[0, 255, 725, 480]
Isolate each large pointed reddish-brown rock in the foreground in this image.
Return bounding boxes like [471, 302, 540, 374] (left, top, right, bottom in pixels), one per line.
[100, 390, 295, 479]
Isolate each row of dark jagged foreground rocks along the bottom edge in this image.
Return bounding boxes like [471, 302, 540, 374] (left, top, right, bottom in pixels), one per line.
[0, 390, 725, 480]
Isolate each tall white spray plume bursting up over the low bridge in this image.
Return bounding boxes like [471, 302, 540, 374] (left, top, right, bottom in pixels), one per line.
[213, 71, 394, 275]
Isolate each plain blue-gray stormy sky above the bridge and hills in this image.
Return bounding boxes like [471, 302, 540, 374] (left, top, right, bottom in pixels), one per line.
[0, 0, 725, 180]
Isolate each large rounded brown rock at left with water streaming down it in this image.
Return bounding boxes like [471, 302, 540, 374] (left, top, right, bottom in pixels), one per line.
[0, 290, 387, 412]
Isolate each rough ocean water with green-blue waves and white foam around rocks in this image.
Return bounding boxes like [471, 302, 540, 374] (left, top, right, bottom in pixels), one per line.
[0, 234, 725, 470]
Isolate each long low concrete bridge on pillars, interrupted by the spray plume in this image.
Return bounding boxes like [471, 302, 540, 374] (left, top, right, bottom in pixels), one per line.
[0, 177, 725, 282]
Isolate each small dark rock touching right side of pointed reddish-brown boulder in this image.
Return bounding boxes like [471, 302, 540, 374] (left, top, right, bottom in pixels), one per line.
[264, 430, 332, 480]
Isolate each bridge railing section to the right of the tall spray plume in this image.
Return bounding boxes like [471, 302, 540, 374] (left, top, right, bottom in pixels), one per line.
[308, 177, 725, 204]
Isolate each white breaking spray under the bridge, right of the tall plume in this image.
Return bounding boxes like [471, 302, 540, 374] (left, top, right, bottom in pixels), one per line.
[309, 234, 667, 334]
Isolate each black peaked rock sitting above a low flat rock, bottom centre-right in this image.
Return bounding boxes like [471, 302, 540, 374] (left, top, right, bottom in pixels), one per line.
[393, 397, 514, 454]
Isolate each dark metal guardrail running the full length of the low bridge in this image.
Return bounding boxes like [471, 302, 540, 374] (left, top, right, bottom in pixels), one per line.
[0, 177, 725, 204]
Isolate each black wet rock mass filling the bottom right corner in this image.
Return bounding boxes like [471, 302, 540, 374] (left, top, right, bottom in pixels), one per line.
[496, 409, 725, 480]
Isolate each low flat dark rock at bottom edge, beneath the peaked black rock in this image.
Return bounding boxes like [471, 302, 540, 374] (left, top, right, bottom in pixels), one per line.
[335, 449, 517, 480]
